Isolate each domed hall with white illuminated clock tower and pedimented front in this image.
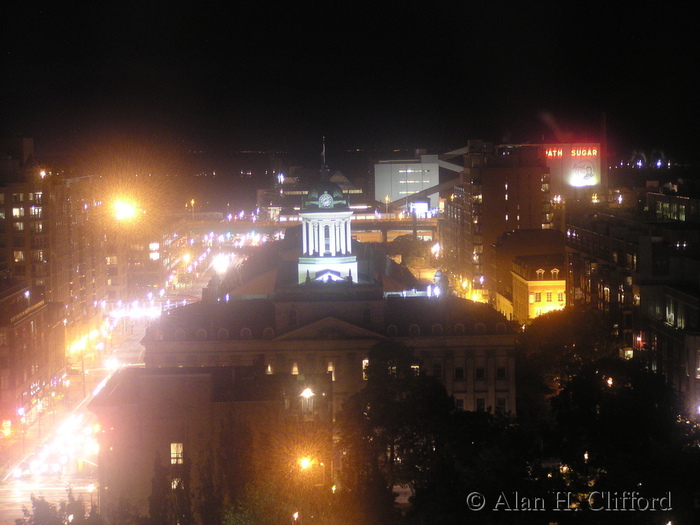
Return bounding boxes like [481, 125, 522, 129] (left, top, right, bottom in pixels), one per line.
[91, 154, 517, 510]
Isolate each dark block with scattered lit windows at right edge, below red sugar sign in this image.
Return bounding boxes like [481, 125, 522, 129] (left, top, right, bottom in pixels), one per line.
[566, 199, 700, 413]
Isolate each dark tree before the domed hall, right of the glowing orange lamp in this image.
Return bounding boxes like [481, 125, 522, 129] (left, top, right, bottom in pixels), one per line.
[339, 342, 454, 522]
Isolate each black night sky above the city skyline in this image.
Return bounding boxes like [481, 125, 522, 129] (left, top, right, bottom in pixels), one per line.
[0, 0, 700, 166]
